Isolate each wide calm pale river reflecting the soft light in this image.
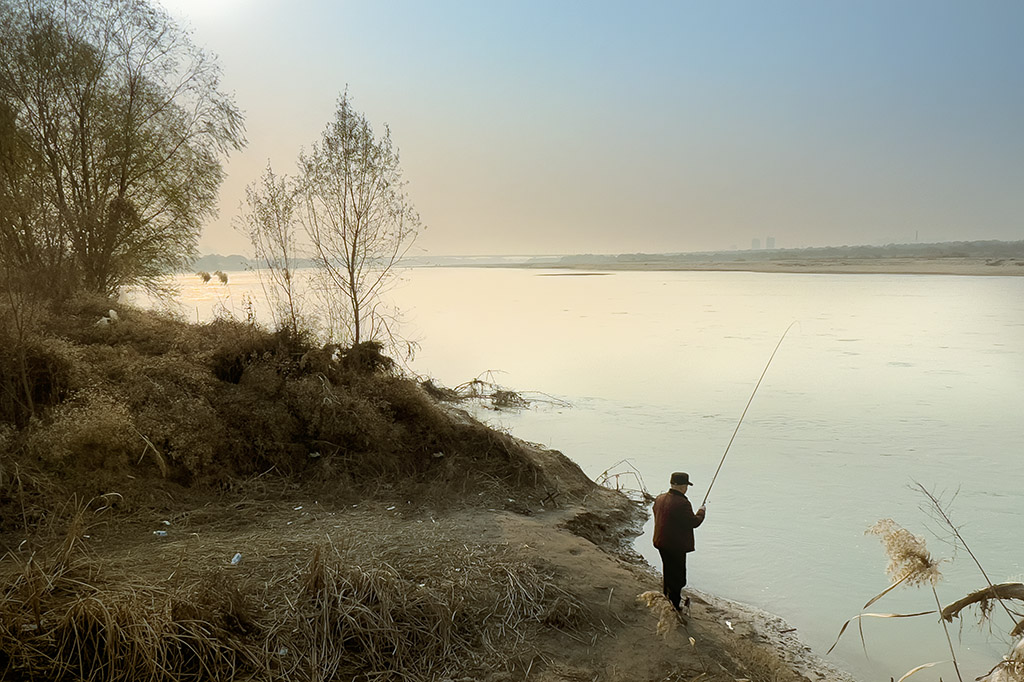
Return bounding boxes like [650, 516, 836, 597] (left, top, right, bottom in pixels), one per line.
[144, 267, 1024, 681]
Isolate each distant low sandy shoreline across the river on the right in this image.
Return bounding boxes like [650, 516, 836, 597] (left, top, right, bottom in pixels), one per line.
[493, 258, 1024, 276]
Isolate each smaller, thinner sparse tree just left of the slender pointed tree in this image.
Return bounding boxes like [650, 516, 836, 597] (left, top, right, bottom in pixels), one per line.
[239, 163, 308, 335]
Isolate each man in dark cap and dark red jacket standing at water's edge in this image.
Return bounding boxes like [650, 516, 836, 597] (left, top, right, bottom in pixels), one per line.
[654, 471, 708, 611]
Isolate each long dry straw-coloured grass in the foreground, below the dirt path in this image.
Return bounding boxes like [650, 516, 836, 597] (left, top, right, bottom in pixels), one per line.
[0, 506, 590, 682]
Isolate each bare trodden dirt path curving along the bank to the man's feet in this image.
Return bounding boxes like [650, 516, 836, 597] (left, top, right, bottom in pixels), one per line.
[39, 495, 849, 682]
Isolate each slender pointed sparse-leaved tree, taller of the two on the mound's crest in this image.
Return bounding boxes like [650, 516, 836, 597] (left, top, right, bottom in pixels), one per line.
[299, 91, 420, 345]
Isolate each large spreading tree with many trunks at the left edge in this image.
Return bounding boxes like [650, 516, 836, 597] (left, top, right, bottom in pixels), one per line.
[0, 0, 245, 293]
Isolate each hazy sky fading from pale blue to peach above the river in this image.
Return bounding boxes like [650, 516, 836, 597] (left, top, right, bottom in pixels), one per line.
[164, 0, 1024, 255]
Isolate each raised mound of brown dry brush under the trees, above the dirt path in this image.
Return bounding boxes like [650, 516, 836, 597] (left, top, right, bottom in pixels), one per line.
[0, 300, 551, 520]
